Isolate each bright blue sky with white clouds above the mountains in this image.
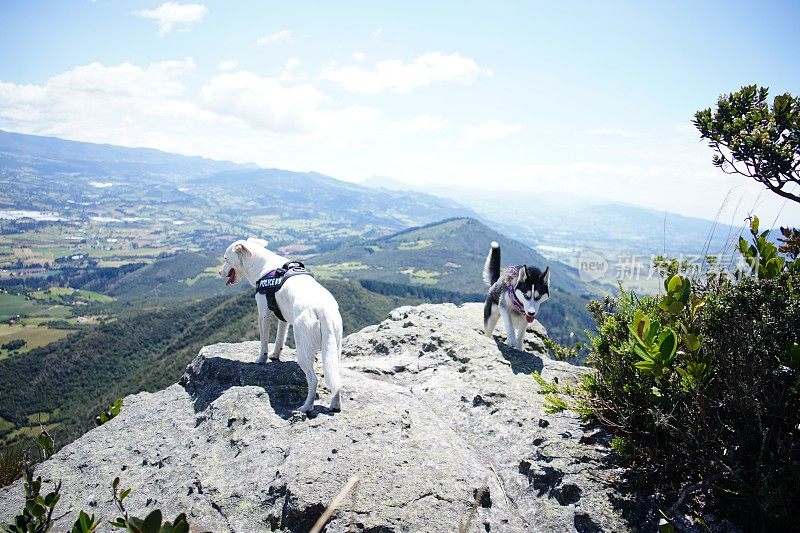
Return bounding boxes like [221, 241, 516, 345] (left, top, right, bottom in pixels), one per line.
[0, 0, 800, 225]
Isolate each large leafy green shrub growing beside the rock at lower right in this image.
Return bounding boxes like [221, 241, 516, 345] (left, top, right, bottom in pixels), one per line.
[579, 230, 800, 530]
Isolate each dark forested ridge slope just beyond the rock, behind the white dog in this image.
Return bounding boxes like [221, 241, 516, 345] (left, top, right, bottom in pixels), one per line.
[0, 280, 420, 447]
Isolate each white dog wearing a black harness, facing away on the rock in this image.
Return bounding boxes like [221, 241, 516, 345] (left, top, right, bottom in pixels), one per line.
[219, 239, 342, 413]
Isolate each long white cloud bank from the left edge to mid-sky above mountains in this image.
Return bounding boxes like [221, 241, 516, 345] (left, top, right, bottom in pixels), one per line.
[0, 58, 382, 151]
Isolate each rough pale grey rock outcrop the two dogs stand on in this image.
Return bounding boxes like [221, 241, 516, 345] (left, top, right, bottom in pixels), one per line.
[0, 304, 633, 533]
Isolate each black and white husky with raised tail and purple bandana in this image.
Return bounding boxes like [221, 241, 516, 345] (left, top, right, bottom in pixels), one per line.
[483, 242, 550, 350]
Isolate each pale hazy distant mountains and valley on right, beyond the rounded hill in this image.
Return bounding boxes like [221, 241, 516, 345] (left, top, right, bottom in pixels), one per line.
[364, 177, 746, 258]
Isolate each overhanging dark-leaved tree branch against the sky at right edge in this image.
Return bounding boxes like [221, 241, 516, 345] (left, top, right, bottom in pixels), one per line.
[693, 85, 800, 202]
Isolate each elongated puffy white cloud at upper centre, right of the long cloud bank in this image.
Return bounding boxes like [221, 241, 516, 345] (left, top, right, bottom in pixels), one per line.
[321, 52, 492, 94]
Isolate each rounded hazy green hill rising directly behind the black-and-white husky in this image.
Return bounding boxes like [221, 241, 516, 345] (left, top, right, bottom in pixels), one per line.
[308, 218, 603, 343]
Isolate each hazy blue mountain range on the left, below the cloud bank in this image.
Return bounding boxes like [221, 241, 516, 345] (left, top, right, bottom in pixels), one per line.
[0, 131, 478, 239]
